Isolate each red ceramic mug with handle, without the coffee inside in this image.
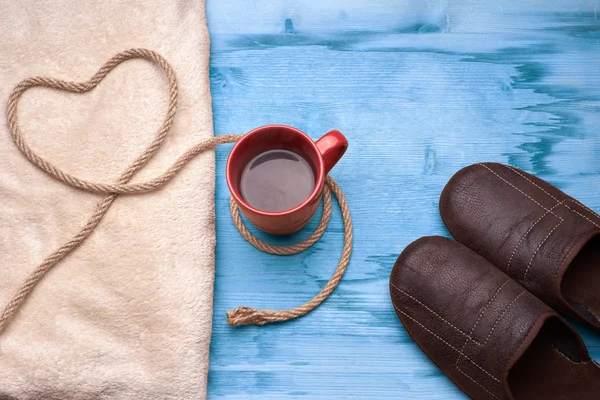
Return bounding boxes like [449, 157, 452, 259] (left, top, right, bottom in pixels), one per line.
[227, 125, 348, 235]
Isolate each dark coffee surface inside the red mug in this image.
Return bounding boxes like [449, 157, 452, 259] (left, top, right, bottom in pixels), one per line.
[240, 150, 315, 212]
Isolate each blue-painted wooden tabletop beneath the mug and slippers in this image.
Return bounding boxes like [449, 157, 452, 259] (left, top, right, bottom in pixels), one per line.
[207, 0, 600, 400]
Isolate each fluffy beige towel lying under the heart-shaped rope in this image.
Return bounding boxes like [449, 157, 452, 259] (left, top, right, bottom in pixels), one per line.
[0, 0, 215, 400]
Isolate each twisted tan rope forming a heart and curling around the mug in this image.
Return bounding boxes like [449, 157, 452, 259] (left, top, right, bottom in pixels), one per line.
[0, 49, 352, 332]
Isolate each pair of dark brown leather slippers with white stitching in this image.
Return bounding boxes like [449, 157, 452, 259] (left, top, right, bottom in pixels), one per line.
[390, 163, 600, 400]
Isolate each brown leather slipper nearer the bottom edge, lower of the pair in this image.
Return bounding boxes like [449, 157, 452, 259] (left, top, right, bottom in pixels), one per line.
[390, 237, 600, 400]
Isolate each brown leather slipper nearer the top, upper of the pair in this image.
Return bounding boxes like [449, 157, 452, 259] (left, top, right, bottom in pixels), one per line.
[440, 163, 600, 334]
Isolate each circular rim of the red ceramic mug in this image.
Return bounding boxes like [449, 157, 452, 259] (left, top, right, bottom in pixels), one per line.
[225, 124, 325, 217]
